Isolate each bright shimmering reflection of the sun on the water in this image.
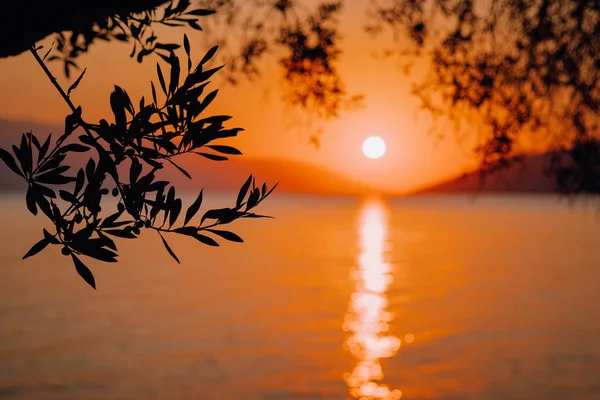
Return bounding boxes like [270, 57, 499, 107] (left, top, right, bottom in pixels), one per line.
[343, 202, 402, 400]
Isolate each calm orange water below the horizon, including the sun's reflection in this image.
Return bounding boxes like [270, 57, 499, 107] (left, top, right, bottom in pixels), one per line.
[0, 196, 600, 400]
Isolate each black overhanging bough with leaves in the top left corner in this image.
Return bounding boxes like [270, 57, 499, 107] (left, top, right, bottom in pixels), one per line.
[0, 0, 214, 77]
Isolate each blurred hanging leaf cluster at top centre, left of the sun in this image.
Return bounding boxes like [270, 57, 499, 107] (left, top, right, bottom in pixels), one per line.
[192, 0, 362, 119]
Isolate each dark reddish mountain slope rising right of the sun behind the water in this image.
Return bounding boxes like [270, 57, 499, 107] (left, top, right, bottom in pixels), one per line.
[412, 154, 556, 194]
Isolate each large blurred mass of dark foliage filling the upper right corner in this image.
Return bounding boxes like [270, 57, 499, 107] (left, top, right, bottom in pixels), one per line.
[369, 0, 600, 193]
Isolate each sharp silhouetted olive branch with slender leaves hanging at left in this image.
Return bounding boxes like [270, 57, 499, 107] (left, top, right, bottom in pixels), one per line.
[0, 37, 276, 288]
